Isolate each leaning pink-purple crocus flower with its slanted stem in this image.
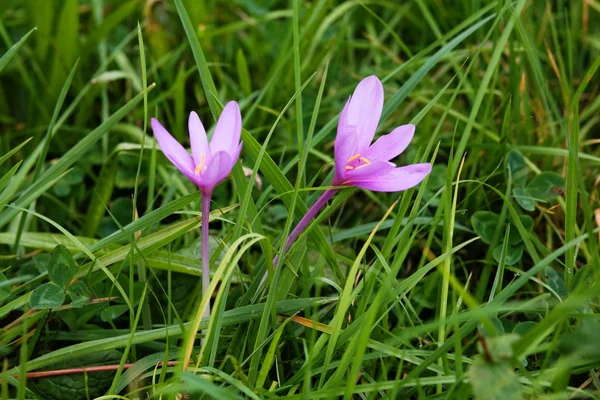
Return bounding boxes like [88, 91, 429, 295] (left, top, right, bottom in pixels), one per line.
[273, 76, 431, 265]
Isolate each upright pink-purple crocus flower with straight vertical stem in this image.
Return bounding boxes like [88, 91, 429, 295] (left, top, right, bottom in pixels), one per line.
[152, 101, 242, 315]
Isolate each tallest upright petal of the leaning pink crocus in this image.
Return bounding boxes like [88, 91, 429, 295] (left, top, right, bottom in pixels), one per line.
[347, 75, 383, 153]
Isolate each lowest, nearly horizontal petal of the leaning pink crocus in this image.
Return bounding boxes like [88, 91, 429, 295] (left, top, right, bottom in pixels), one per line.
[350, 163, 431, 192]
